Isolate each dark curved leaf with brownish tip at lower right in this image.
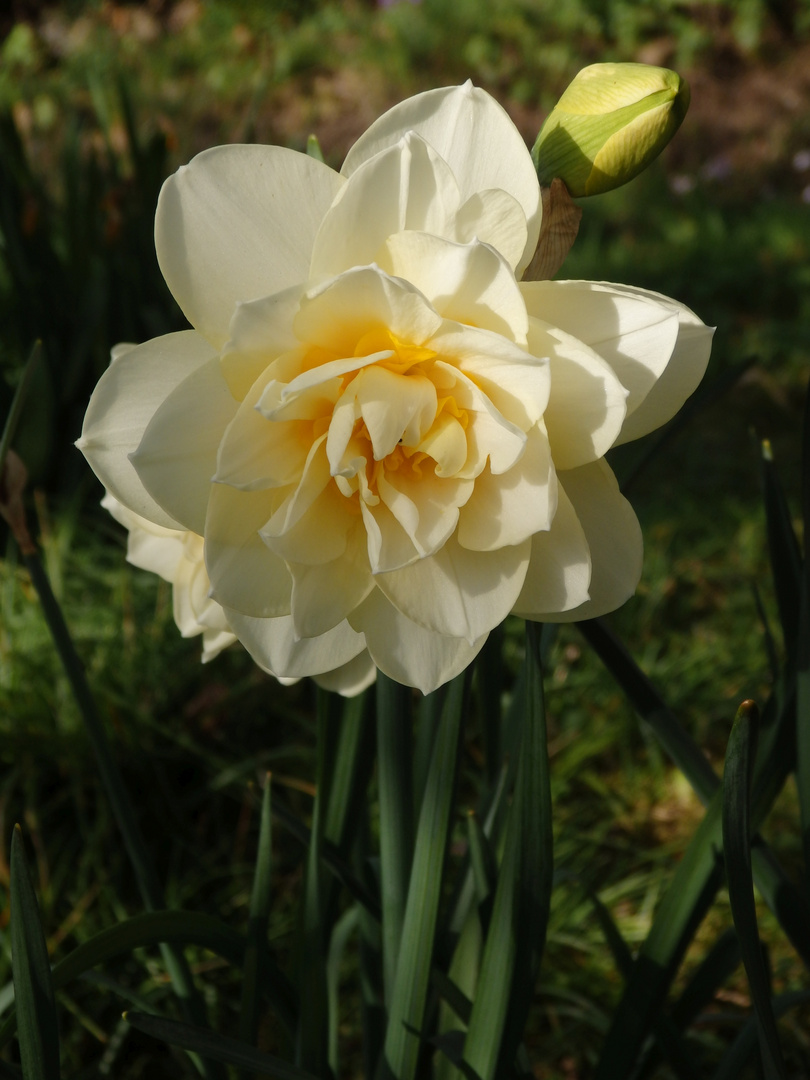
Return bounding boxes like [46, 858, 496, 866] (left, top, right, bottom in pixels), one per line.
[723, 701, 785, 1080]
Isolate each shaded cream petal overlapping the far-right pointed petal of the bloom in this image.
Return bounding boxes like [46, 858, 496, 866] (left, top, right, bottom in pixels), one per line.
[521, 281, 678, 416]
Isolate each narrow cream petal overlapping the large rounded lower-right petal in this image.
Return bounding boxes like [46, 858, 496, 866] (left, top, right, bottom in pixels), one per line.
[513, 484, 591, 621]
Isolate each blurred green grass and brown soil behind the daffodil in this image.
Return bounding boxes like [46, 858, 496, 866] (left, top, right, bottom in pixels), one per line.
[0, 0, 810, 1080]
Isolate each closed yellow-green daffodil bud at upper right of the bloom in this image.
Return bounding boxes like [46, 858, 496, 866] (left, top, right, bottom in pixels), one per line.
[531, 64, 689, 197]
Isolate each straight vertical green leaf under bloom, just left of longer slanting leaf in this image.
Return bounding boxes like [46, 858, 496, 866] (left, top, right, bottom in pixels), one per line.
[377, 672, 414, 1004]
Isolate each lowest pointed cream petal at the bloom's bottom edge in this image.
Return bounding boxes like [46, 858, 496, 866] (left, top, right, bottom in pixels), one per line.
[351, 589, 487, 693]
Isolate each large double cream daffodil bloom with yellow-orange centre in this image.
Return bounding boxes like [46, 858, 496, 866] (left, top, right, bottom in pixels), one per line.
[74, 84, 711, 692]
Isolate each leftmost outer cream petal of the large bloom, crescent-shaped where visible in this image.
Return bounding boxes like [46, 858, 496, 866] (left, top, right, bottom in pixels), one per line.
[76, 330, 216, 529]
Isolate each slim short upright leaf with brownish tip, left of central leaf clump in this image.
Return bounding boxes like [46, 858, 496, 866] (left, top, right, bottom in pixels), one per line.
[239, 773, 272, 1067]
